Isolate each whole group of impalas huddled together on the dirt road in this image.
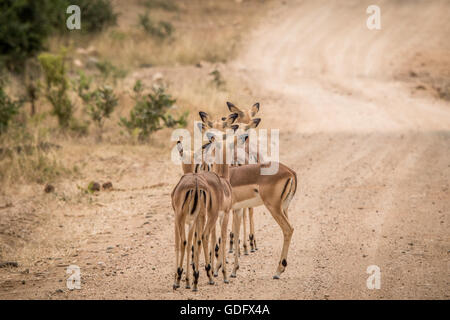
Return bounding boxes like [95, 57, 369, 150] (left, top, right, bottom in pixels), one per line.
[171, 102, 297, 291]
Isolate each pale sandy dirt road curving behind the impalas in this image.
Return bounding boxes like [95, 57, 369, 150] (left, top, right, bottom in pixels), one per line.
[0, 1, 450, 299]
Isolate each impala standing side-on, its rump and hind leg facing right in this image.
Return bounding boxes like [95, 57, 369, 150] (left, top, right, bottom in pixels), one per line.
[177, 113, 297, 279]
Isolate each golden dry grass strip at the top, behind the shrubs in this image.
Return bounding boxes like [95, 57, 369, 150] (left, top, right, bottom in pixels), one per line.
[51, 0, 266, 70]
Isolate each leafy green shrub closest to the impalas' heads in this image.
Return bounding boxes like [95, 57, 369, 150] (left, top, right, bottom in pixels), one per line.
[119, 81, 188, 141]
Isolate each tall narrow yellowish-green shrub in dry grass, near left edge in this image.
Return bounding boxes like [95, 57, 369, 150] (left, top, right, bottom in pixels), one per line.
[38, 52, 74, 129]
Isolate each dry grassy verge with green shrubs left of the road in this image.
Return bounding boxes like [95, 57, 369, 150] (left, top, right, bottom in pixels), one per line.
[0, 0, 265, 191]
